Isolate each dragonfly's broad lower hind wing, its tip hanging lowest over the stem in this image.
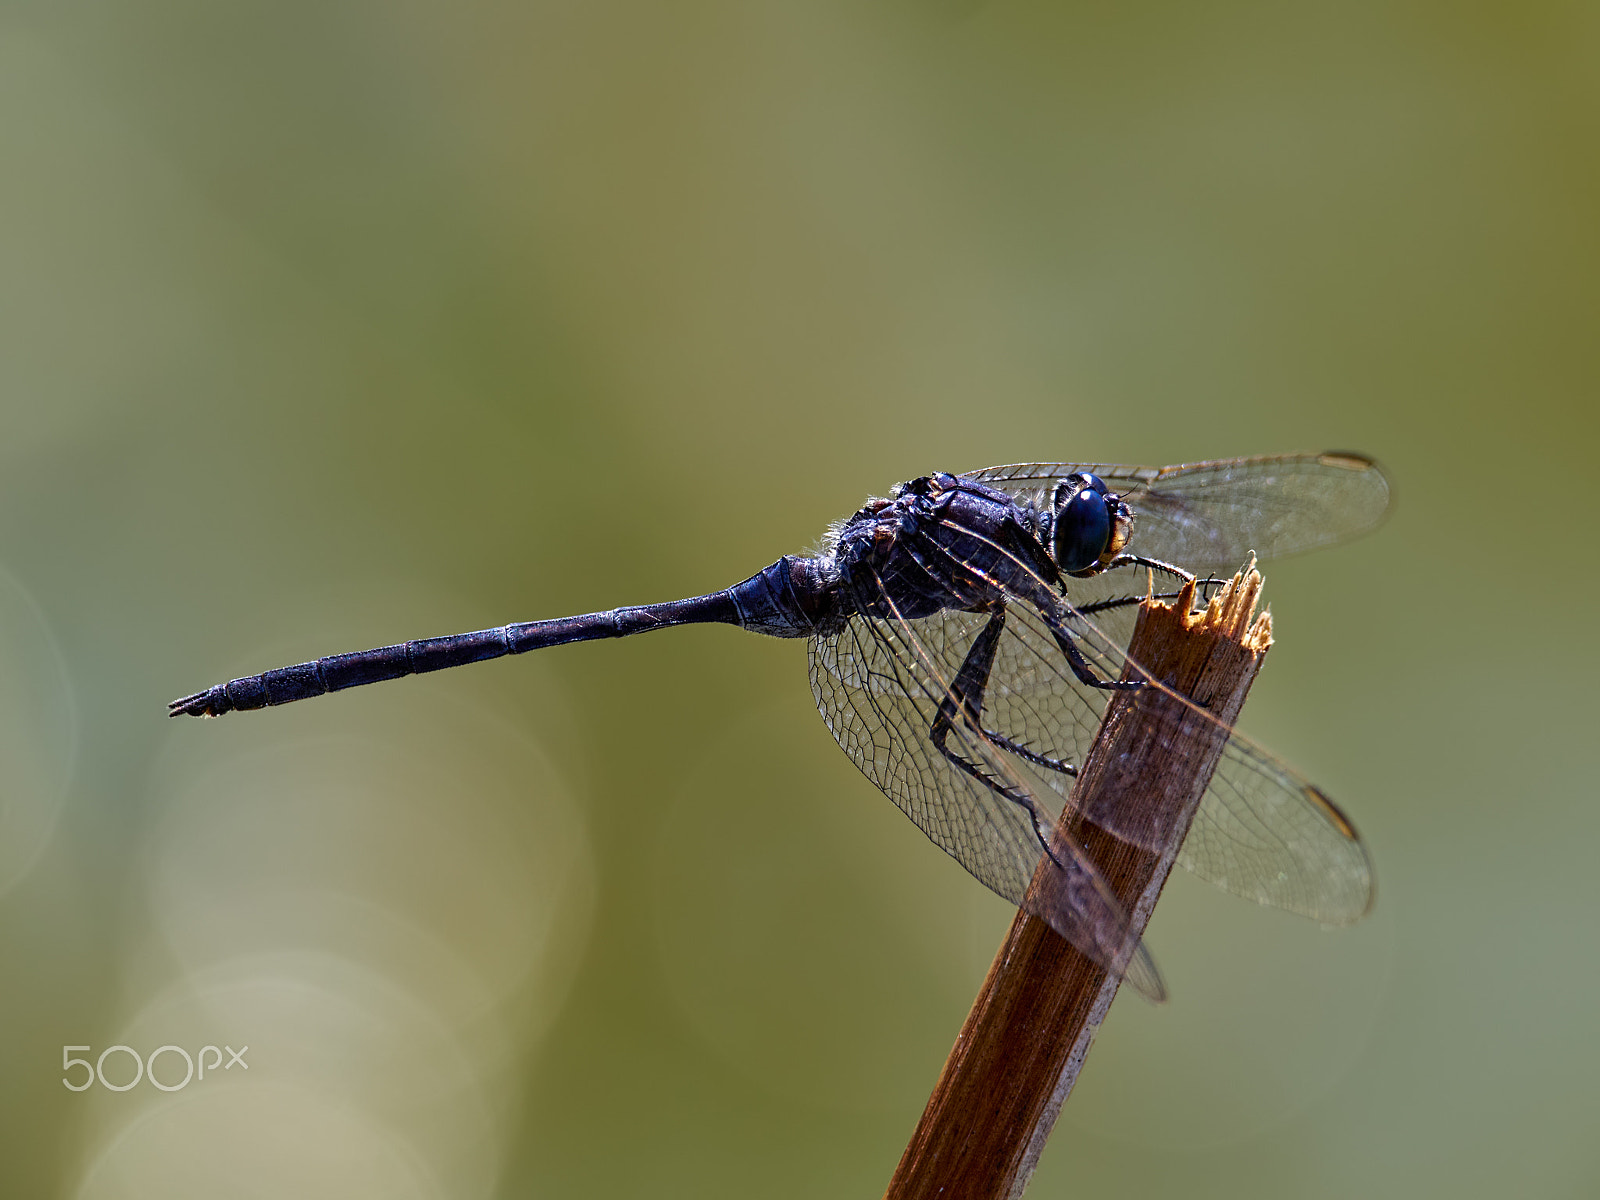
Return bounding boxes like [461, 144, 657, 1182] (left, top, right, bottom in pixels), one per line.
[810, 569, 1165, 1000]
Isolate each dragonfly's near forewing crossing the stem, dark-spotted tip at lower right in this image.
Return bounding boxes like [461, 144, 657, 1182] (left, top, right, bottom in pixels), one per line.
[925, 512, 1373, 925]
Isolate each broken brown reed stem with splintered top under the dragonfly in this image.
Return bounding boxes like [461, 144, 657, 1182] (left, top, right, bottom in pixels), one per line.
[885, 565, 1272, 1200]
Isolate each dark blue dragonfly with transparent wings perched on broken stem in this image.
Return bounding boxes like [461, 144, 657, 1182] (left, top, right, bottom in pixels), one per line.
[168, 451, 1389, 1000]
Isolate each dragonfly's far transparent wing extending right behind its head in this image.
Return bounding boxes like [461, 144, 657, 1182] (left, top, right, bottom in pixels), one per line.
[966, 453, 1390, 574]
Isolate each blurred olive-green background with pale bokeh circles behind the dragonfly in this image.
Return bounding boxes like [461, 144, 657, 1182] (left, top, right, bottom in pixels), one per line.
[0, 0, 1600, 1200]
